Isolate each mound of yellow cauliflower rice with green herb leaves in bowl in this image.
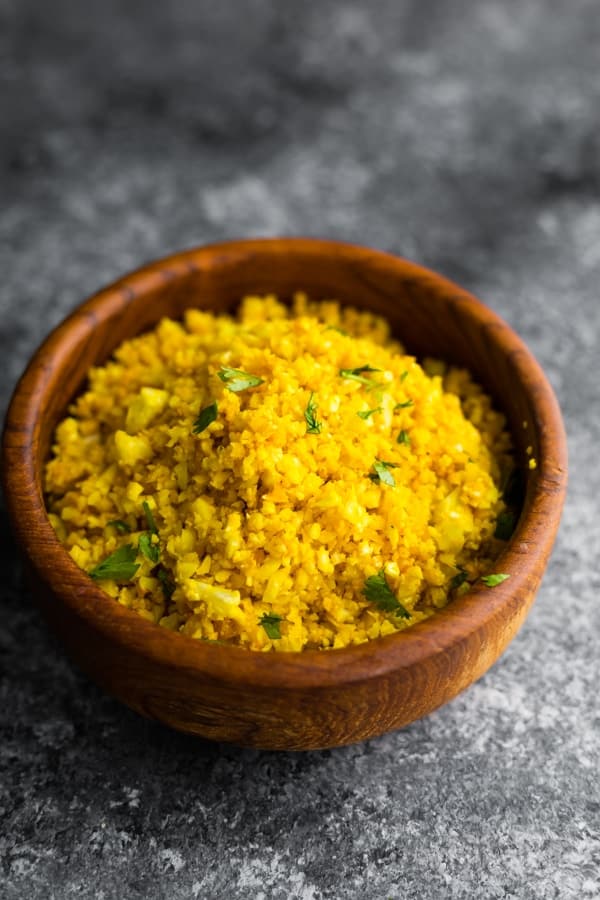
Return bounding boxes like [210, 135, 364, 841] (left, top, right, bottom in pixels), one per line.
[45, 294, 510, 651]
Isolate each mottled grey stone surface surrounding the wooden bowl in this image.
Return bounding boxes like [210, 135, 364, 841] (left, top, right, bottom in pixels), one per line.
[0, 0, 600, 900]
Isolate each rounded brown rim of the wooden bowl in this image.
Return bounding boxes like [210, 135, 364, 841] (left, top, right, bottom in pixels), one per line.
[2, 237, 567, 690]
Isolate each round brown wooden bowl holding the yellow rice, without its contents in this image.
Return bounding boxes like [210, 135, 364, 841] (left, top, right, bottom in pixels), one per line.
[3, 238, 567, 750]
